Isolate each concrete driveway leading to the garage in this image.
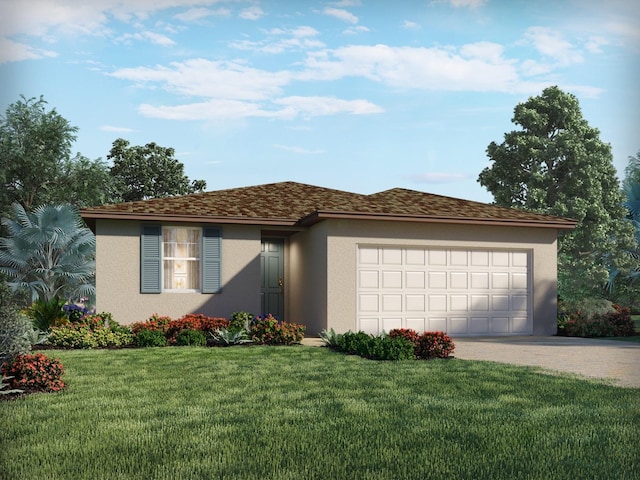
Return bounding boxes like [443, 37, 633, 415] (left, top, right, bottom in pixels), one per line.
[453, 336, 640, 388]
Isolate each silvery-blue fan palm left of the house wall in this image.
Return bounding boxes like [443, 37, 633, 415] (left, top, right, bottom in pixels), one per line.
[0, 203, 95, 302]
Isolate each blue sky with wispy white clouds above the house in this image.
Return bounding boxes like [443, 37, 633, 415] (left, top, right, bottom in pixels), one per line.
[0, 0, 640, 202]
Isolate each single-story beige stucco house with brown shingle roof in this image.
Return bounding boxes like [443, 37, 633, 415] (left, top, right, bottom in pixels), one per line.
[81, 182, 576, 335]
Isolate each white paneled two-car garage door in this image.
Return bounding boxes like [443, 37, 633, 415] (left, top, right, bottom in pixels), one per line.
[357, 246, 532, 335]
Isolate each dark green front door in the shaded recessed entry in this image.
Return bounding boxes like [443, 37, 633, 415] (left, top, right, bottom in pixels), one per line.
[260, 238, 284, 320]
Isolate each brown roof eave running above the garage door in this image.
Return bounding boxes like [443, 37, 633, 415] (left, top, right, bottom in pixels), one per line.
[298, 211, 578, 230]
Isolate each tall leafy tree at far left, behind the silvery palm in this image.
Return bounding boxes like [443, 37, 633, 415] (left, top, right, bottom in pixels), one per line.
[0, 96, 111, 215]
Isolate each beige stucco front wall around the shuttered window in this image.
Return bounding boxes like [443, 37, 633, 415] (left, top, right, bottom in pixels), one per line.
[96, 220, 260, 324]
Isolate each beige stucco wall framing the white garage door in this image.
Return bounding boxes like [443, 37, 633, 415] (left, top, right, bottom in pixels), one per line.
[322, 220, 557, 335]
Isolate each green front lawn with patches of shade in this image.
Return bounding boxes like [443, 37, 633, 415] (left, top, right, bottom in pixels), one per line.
[0, 347, 640, 480]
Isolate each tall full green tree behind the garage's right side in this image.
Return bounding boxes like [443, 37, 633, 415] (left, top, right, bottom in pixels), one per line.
[478, 87, 634, 299]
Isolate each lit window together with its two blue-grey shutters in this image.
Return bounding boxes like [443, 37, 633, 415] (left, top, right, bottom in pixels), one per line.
[140, 225, 222, 293]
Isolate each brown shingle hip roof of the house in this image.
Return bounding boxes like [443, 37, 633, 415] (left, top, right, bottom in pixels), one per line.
[81, 182, 576, 228]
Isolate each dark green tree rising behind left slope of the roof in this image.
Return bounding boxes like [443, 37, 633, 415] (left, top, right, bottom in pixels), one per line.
[107, 138, 207, 202]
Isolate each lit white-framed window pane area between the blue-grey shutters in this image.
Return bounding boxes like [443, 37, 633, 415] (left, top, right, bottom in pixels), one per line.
[162, 227, 201, 291]
